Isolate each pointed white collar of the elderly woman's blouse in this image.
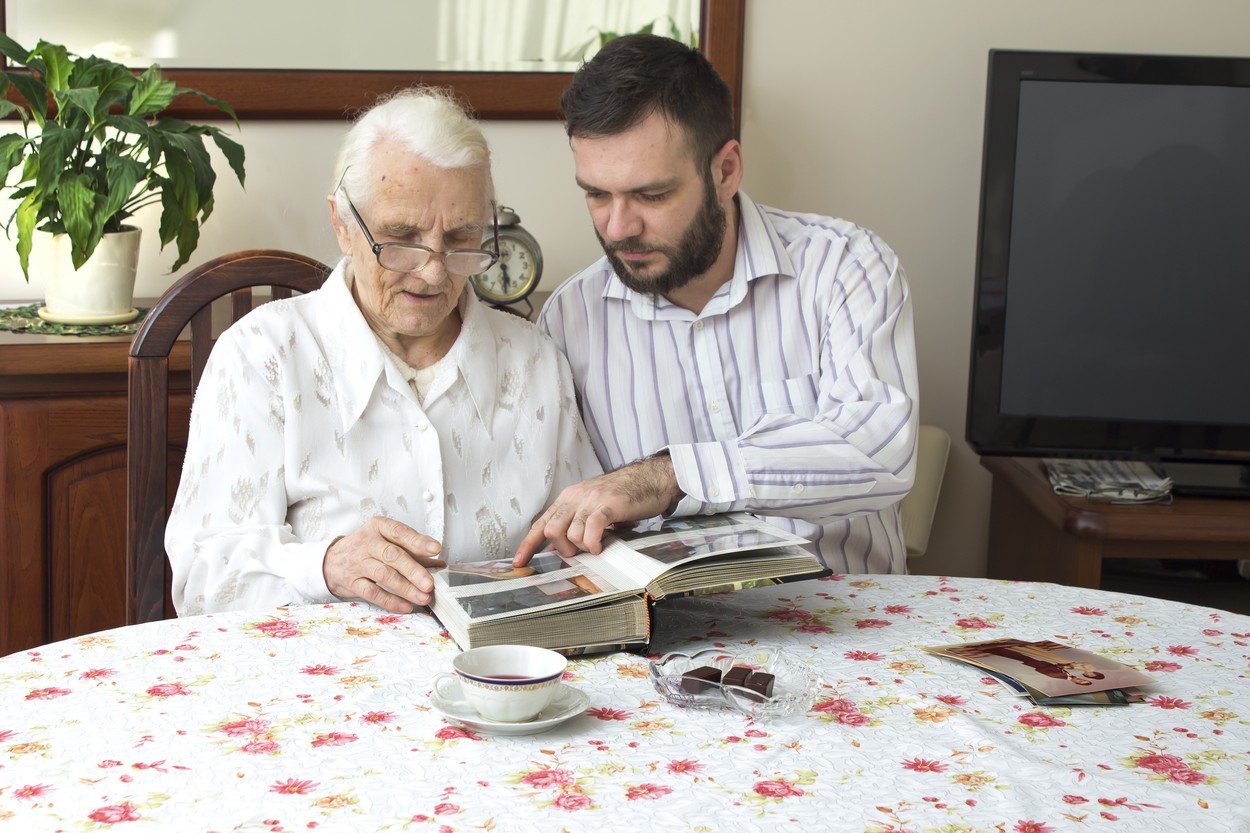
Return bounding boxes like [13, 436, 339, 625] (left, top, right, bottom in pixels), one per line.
[316, 258, 499, 433]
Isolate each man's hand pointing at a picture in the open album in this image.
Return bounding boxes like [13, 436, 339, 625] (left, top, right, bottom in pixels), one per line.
[513, 453, 683, 567]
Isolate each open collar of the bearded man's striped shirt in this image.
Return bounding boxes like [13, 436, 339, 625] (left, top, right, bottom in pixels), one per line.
[603, 190, 798, 319]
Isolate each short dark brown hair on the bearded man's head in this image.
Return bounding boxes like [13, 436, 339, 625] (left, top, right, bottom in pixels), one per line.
[560, 35, 734, 174]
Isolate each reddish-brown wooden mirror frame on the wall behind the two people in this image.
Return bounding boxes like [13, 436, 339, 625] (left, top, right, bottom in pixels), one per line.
[0, 0, 746, 129]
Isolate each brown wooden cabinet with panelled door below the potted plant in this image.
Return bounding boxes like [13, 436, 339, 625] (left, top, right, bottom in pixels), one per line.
[0, 333, 191, 655]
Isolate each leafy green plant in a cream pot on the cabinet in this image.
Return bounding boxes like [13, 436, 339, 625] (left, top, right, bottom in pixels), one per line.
[0, 33, 244, 323]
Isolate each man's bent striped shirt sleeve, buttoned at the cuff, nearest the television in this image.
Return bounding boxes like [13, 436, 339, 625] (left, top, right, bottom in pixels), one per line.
[669, 241, 918, 520]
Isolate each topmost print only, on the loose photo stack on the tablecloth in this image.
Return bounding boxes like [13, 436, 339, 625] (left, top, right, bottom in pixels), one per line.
[924, 639, 1155, 697]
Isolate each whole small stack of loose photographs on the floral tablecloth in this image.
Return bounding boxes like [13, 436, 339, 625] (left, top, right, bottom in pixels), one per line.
[921, 639, 1155, 705]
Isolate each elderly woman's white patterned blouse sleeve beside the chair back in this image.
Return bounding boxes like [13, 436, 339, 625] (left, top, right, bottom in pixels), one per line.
[165, 330, 336, 615]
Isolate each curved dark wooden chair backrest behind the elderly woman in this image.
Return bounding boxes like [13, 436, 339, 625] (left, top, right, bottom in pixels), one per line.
[126, 249, 330, 624]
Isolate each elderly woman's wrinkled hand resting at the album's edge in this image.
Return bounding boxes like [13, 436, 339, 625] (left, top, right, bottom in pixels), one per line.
[321, 517, 446, 613]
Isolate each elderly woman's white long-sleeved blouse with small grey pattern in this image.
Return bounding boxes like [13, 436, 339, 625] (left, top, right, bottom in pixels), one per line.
[165, 260, 601, 615]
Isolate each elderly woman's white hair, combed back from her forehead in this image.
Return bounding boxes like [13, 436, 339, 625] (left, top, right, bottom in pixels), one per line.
[330, 86, 495, 221]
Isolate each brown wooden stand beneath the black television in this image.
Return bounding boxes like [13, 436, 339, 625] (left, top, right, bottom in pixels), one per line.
[981, 457, 1250, 588]
